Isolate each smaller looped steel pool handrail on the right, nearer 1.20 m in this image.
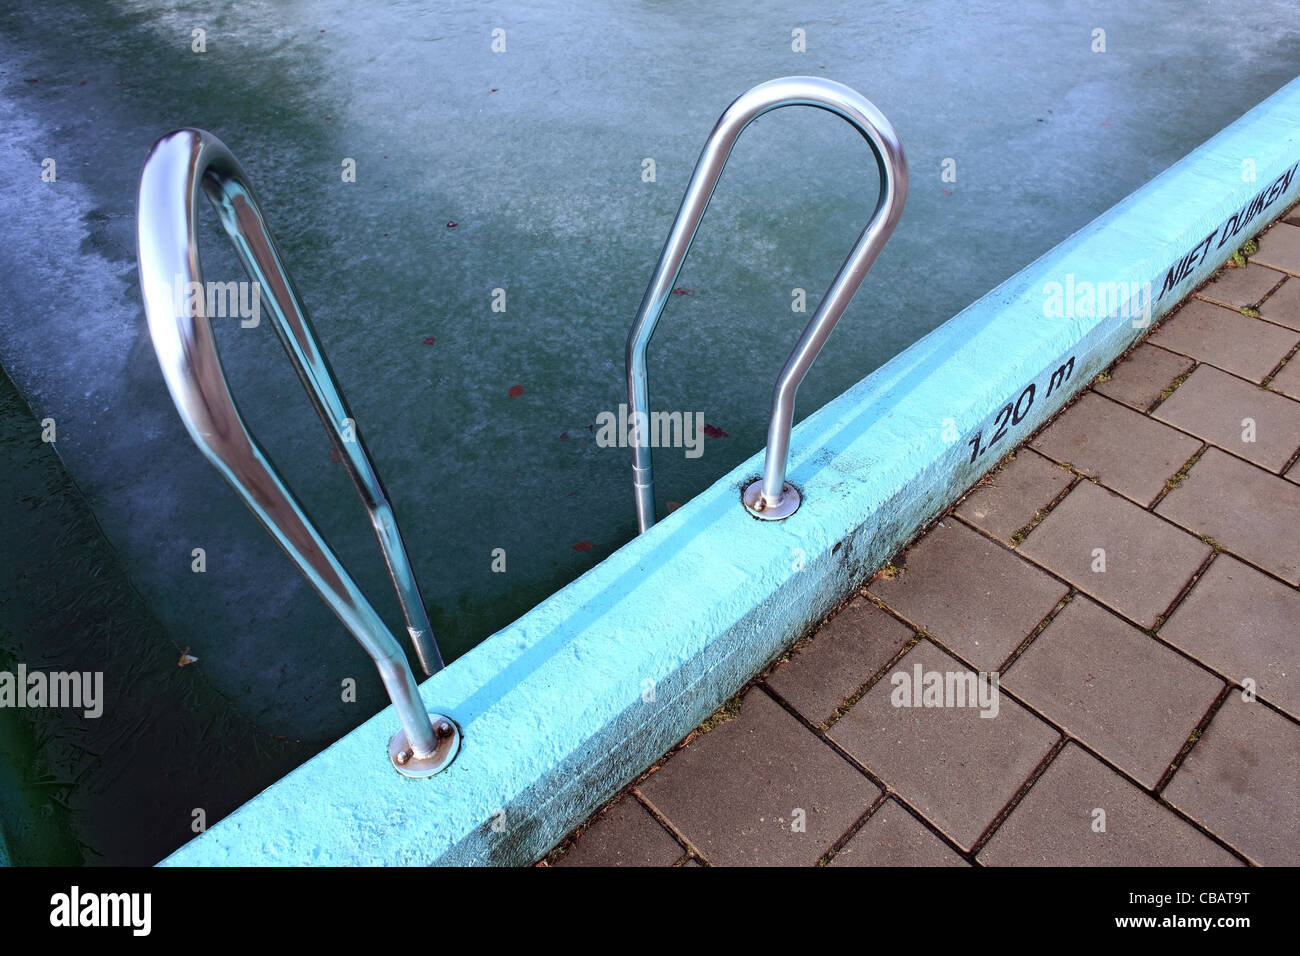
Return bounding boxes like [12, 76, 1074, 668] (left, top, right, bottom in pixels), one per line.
[627, 77, 907, 532]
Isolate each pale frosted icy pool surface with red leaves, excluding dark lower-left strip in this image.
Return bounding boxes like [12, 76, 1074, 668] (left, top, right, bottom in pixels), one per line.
[0, 3, 1300, 868]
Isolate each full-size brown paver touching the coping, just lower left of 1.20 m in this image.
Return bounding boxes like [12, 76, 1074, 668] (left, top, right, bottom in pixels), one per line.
[871, 520, 1069, 671]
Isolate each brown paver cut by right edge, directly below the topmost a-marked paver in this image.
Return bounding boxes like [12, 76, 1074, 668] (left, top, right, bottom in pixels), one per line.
[1159, 447, 1300, 584]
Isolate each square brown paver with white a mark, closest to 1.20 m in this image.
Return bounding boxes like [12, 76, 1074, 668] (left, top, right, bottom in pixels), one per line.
[1021, 478, 1222, 627]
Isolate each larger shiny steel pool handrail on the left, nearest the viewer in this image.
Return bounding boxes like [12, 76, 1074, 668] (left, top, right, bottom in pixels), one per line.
[137, 129, 459, 777]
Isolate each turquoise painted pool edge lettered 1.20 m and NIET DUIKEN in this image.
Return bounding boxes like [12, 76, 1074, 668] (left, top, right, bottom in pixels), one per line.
[163, 81, 1300, 865]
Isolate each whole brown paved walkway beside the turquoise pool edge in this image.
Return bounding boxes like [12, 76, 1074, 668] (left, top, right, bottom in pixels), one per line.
[550, 209, 1300, 866]
